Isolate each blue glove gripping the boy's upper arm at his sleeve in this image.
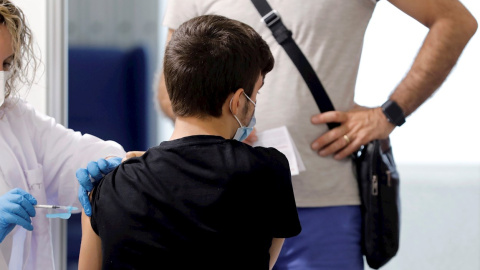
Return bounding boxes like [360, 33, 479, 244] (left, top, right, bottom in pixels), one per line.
[76, 157, 122, 216]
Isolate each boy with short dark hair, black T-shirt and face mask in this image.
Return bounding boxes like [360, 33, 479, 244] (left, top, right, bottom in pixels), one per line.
[79, 15, 301, 269]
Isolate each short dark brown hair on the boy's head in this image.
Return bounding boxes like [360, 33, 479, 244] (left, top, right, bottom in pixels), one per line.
[163, 15, 274, 117]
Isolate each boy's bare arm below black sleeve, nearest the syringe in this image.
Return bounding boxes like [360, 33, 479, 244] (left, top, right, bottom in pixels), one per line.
[78, 205, 102, 270]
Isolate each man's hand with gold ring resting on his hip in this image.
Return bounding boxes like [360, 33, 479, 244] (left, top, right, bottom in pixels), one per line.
[311, 106, 395, 160]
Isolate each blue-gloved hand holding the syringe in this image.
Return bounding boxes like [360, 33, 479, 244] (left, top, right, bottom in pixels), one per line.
[0, 188, 37, 243]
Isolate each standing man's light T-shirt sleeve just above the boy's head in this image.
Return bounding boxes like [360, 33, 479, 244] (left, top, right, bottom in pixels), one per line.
[163, 0, 203, 29]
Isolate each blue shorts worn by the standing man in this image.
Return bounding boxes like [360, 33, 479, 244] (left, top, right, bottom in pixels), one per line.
[273, 206, 364, 270]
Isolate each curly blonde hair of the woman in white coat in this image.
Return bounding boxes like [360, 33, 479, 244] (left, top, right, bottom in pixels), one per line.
[0, 0, 40, 98]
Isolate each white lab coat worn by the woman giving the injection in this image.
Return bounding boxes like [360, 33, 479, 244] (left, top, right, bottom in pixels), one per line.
[0, 98, 125, 270]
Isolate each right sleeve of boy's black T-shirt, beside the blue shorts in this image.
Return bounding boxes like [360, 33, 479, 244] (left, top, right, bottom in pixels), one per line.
[269, 148, 302, 238]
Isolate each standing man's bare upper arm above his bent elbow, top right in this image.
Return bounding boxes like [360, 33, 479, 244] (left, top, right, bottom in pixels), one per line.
[389, 0, 476, 29]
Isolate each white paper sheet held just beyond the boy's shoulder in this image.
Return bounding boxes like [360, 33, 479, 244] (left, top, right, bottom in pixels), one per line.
[253, 126, 305, 175]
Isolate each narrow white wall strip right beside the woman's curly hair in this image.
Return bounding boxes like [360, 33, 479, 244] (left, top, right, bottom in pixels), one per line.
[12, 0, 47, 113]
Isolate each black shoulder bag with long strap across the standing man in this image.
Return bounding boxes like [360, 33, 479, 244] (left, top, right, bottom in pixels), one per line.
[252, 0, 400, 269]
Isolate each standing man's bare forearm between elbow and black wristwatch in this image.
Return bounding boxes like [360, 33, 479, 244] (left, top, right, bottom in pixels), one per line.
[390, 1, 477, 116]
